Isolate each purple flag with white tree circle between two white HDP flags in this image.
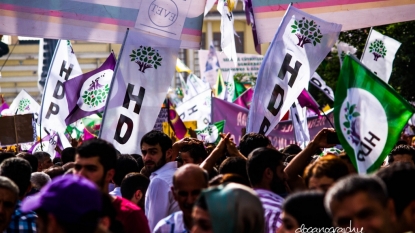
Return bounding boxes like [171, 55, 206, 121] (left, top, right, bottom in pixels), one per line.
[64, 53, 116, 125]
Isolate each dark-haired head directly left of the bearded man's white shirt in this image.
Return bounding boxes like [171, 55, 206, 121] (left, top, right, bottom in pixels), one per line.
[121, 172, 150, 209]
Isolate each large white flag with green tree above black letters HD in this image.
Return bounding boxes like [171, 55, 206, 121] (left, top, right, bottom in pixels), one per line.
[99, 31, 180, 154]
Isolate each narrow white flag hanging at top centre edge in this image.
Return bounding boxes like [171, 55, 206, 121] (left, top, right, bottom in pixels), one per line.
[217, 0, 238, 66]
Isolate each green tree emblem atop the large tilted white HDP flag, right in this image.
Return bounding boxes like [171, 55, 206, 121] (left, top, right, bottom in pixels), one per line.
[291, 17, 323, 48]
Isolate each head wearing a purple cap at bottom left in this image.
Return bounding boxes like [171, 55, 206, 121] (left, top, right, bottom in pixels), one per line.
[21, 175, 102, 233]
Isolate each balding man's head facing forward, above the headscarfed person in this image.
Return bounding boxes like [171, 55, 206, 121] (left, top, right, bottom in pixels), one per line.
[172, 164, 208, 222]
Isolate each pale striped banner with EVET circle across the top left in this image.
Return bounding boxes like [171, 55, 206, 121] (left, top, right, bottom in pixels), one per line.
[0, 0, 206, 49]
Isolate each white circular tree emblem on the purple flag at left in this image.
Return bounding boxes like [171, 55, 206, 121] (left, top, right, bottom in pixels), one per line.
[82, 74, 110, 107]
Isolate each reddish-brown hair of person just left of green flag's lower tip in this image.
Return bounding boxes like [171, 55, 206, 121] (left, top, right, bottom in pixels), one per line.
[303, 155, 349, 187]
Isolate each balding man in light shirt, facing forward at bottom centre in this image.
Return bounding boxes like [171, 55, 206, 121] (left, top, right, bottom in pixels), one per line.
[153, 164, 208, 233]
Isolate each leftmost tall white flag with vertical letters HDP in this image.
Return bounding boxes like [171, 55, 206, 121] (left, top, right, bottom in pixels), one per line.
[38, 40, 82, 132]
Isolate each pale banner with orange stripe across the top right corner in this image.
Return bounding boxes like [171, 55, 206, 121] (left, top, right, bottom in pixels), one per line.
[252, 0, 415, 44]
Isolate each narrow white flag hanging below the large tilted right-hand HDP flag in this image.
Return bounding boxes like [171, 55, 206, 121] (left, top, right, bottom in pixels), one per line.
[290, 100, 310, 149]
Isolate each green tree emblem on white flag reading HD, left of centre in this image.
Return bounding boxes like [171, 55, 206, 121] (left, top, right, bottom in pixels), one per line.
[130, 46, 163, 73]
